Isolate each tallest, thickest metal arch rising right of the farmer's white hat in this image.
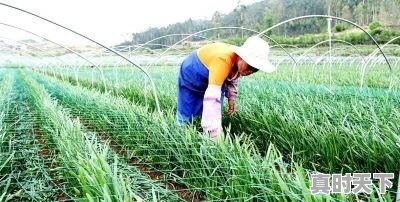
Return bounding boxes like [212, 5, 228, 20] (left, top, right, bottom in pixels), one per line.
[259, 15, 392, 72]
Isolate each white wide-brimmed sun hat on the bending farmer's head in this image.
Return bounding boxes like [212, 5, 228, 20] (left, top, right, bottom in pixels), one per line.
[235, 36, 276, 73]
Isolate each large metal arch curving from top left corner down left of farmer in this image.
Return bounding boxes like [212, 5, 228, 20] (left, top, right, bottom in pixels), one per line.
[0, 2, 162, 115]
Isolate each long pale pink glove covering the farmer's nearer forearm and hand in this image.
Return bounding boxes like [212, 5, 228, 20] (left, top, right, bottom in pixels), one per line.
[201, 84, 222, 139]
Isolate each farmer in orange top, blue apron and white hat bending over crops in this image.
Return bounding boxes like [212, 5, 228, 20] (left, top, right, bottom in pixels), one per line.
[176, 36, 275, 139]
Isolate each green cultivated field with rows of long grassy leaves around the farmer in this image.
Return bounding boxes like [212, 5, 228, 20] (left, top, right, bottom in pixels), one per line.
[0, 46, 400, 201]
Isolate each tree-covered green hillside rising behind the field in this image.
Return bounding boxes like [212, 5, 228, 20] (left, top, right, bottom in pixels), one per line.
[120, 0, 400, 48]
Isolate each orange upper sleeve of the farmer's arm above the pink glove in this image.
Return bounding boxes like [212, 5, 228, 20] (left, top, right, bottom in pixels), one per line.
[208, 57, 232, 86]
